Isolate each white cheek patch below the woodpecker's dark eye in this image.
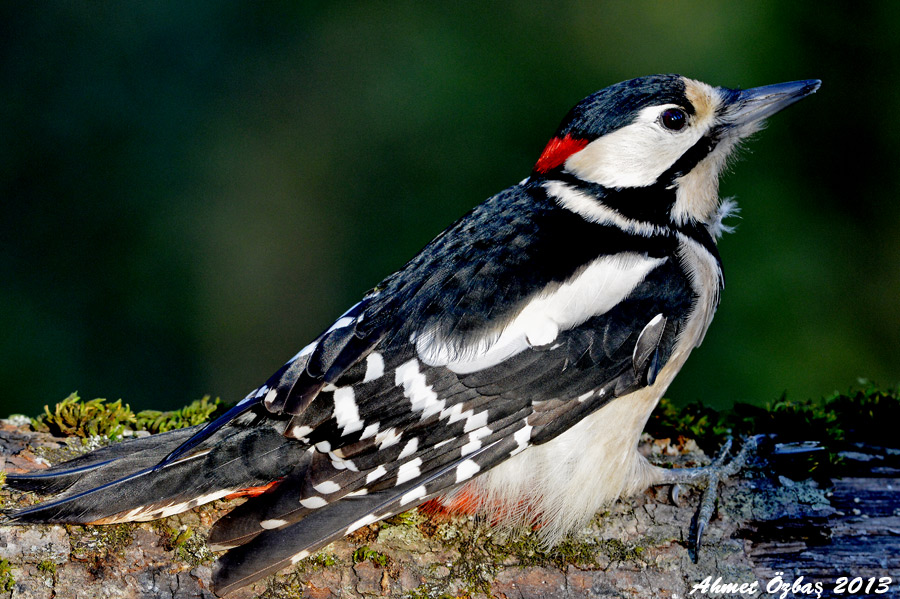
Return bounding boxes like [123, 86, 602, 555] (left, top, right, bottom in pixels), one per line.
[565, 104, 708, 188]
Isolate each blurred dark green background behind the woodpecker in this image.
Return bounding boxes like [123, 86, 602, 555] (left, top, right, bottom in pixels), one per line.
[0, 0, 900, 415]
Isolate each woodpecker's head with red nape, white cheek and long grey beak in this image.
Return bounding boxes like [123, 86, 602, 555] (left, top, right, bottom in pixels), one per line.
[533, 75, 820, 232]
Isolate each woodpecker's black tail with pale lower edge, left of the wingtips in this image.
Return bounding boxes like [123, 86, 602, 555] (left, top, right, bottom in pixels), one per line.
[9, 427, 309, 524]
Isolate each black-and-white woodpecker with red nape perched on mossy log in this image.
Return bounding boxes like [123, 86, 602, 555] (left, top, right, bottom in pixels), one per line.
[7, 75, 820, 595]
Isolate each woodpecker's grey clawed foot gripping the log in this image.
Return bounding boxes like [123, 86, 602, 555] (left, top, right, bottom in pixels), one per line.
[655, 437, 757, 563]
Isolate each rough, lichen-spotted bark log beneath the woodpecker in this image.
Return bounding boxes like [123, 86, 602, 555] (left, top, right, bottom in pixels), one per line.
[0, 421, 900, 599]
